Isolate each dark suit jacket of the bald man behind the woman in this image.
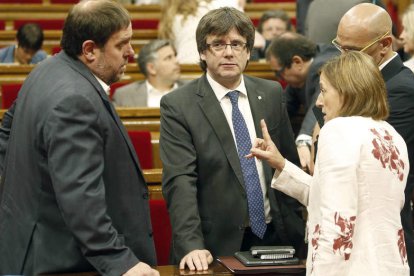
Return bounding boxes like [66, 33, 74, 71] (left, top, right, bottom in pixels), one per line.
[381, 56, 414, 274]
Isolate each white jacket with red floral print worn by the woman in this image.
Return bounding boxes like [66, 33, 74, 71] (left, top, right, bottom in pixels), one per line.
[272, 117, 409, 276]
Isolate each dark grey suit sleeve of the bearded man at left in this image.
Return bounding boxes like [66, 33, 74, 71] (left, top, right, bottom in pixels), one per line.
[42, 95, 138, 275]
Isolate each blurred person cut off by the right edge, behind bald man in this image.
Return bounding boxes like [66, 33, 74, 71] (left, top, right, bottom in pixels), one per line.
[400, 4, 414, 71]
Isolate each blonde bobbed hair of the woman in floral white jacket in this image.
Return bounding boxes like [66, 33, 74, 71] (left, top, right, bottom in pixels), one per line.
[321, 51, 389, 120]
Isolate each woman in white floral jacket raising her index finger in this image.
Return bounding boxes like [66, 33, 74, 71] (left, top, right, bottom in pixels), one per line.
[251, 51, 410, 276]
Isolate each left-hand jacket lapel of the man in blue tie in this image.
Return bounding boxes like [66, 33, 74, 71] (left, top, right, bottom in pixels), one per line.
[197, 75, 244, 189]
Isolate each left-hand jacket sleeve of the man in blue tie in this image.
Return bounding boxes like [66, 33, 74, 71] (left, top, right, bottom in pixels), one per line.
[160, 97, 205, 261]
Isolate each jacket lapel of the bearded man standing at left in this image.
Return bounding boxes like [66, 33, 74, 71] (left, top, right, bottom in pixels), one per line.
[59, 51, 139, 168]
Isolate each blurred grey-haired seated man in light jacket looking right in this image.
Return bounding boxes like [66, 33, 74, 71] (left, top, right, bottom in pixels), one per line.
[113, 39, 184, 107]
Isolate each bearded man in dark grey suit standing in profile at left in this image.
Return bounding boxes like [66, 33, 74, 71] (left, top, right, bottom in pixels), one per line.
[0, 0, 159, 275]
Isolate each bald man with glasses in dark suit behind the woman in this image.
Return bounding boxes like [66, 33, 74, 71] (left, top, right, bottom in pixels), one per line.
[332, 4, 414, 275]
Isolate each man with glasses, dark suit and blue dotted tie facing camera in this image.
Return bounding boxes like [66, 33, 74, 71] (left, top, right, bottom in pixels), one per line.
[160, 7, 305, 270]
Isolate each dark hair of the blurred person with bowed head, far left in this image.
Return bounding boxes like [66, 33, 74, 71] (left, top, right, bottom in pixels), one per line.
[16, 23, 43, 51]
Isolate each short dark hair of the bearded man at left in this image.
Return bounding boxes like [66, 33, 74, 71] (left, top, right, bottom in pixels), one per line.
[60, 0, 131, 58]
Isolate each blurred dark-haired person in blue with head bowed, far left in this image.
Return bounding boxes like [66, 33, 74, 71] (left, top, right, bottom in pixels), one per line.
[0, 23, 47, 64]
